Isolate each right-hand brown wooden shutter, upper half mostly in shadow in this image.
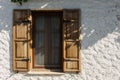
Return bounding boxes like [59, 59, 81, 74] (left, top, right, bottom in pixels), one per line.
[63, 9, 80, 72]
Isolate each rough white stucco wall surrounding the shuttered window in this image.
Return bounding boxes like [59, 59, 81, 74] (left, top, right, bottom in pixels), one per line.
[0, 0, 120, 80]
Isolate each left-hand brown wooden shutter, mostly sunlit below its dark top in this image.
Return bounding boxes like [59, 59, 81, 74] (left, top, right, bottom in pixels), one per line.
[13, 10, 31, 72]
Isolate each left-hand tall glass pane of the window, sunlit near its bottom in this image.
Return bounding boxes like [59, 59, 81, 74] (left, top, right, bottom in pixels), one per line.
[34, 16, 45, 65]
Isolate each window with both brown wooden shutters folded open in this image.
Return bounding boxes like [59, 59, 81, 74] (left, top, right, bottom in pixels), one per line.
[13, 9, 80, 72]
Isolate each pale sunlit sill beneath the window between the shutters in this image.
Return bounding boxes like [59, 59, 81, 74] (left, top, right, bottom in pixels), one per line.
[28, 70, 65, 75]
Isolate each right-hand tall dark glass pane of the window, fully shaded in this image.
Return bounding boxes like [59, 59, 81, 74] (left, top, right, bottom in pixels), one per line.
[51, 16, 61, 66]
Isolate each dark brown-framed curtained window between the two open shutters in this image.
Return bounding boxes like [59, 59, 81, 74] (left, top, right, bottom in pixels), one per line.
[32, 11, 62, 69]
